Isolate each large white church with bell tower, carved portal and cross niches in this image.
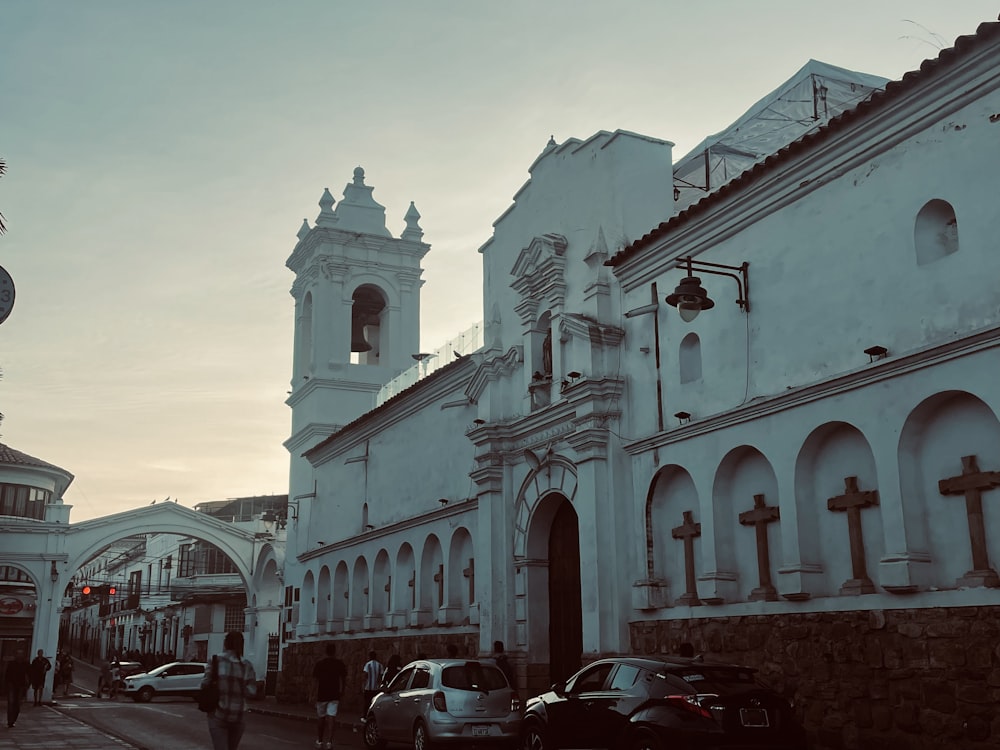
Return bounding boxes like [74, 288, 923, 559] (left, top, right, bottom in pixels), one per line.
[278, 23, 1000, 748]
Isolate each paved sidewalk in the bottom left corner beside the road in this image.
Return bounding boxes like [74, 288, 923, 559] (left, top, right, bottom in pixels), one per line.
[0, 700, 136, 750]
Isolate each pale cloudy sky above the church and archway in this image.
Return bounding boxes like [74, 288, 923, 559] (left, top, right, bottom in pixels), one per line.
[0, 0, 998, 521]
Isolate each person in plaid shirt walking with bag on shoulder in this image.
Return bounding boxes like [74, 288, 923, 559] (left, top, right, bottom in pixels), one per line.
[202, 630, 257, 750]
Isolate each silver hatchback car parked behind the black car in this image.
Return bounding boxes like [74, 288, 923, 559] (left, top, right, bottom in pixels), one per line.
[365, 659, 521, 750]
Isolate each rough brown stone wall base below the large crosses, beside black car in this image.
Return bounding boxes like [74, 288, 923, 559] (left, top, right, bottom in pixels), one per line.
[630, 607, 1000, 750]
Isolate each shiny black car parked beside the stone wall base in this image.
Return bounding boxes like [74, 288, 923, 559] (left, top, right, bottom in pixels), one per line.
[521, 656, 806, 750]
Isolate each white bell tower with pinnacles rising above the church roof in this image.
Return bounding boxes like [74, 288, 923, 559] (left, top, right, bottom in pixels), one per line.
[285, 167, 430, 464]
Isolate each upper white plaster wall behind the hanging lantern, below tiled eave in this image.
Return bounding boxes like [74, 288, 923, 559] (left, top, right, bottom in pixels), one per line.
[626, 92, 1000, 434]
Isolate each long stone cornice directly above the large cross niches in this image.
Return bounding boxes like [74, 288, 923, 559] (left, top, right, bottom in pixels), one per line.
[624, 326, 1000, 455]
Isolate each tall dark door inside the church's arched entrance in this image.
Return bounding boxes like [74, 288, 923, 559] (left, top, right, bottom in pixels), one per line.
[548, 498, 583, 682]
